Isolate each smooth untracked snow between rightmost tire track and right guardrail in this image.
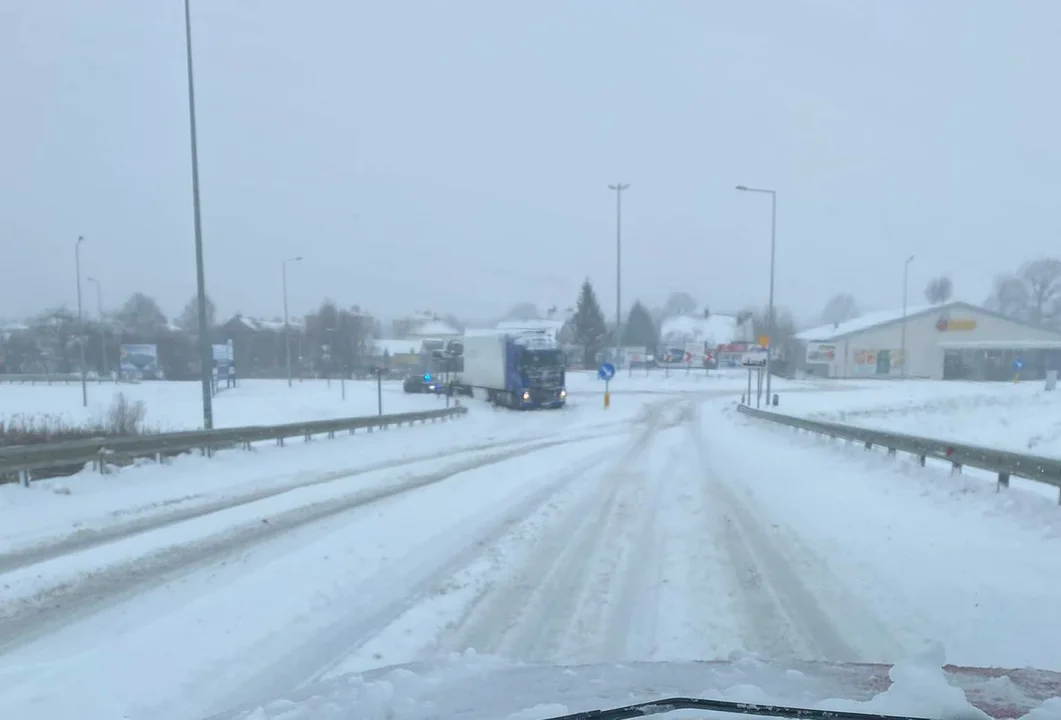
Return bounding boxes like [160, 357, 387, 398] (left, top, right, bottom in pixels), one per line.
[705, 411, 1061, 668]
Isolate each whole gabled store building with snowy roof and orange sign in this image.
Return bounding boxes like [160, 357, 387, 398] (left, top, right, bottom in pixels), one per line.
[796, 302, 1061, 381]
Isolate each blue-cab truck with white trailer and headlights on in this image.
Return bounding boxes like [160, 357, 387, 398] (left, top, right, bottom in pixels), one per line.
[459, 330, 568, 409]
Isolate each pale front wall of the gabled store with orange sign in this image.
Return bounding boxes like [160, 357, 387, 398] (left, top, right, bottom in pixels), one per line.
[830, 306, 1061, 380]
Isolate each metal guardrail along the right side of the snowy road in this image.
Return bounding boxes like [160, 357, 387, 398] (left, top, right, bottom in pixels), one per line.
[737, 405, 1061, 505]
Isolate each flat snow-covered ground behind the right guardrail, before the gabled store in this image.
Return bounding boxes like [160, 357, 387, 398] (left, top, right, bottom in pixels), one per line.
[778, 381, 1061, 457]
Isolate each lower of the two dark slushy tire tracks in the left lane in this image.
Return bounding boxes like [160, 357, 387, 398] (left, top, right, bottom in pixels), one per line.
[0, 430, 615, 652]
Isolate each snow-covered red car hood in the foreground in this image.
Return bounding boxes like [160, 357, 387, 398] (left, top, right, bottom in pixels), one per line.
[204, 653, 1061, 720]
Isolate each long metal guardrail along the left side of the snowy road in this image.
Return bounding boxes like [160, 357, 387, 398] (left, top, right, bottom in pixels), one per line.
[0, 406, 468, 487]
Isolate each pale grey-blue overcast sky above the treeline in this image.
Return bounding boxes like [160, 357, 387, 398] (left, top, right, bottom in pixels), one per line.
[0, 0, 1061, 319]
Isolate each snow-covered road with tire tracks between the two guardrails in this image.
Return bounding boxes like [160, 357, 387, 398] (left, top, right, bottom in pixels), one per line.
[0, 394, 1061, 720]
